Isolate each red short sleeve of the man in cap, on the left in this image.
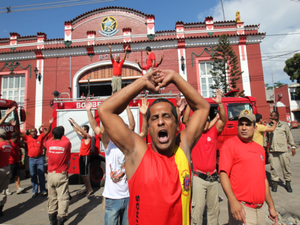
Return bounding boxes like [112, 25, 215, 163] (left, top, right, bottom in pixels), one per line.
[219, 141, 234, 176]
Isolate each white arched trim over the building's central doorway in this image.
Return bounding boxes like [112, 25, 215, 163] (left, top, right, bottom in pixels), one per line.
[72, 60, 141, 99]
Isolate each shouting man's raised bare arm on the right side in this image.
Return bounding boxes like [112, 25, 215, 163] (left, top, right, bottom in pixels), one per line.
[155, 70, 210, 156]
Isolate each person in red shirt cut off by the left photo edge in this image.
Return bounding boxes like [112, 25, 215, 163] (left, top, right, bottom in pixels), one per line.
[0, 128, 12, 217]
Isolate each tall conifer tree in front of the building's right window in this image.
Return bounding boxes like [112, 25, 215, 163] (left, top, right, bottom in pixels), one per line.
[210, 34, 244, 96]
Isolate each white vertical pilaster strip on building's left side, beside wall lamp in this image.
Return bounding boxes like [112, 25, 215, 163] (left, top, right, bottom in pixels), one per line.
[32, 59, 44, 129]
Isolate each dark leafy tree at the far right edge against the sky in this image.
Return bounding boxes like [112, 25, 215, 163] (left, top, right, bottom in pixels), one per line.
[283, 53, 300, 84]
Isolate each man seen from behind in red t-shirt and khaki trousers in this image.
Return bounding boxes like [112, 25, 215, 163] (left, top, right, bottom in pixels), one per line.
[45, 126, 71, 224]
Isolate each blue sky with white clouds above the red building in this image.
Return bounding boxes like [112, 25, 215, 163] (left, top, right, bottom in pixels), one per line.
[0, 0, 300, 85]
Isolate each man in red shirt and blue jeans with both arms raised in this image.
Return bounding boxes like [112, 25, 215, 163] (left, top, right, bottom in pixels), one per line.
[15, 118, 53, 198]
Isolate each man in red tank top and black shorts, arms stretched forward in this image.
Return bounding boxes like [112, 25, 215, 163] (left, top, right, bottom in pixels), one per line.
[69, 118, 93, 197]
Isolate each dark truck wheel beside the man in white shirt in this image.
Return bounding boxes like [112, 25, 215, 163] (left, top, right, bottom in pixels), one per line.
[90, 160, 105, 187]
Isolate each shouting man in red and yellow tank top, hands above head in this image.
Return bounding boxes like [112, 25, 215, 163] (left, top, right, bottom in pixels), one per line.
[97, 70, 210, 225]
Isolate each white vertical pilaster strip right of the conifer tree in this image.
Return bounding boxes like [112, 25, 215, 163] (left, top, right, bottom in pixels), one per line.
[239, 45, 251, 96]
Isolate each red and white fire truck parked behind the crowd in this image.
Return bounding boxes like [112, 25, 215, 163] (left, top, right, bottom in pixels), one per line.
[52, 94, 257, 186]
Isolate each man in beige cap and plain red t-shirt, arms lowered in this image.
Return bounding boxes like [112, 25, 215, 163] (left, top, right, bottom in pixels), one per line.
[219, 110, 278, 225]
